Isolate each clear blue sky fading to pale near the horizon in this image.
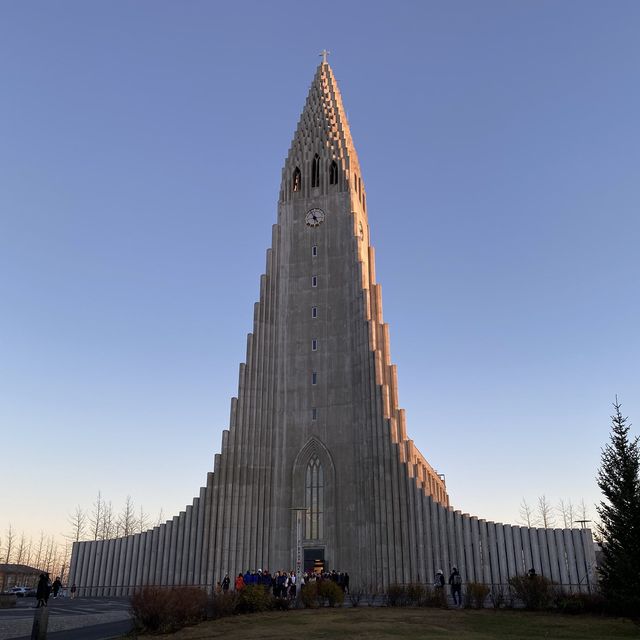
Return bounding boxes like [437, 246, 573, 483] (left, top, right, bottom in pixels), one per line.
[0, 0, 640, 535]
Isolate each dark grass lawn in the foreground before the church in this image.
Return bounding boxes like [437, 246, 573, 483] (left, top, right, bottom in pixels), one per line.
[145, 607, 640, 640]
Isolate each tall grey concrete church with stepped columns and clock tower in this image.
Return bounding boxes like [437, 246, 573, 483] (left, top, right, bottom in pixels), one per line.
[69, 60, 595, 596]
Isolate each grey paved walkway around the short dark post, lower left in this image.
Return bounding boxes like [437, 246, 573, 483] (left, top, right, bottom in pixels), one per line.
[0, 598, 131, 640]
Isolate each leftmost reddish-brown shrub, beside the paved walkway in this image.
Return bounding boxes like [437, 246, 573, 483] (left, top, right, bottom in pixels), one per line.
[131, 587, 207, 633]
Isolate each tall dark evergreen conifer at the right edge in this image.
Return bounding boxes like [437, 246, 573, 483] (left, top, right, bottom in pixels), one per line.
[598, 396, 640, 614]
